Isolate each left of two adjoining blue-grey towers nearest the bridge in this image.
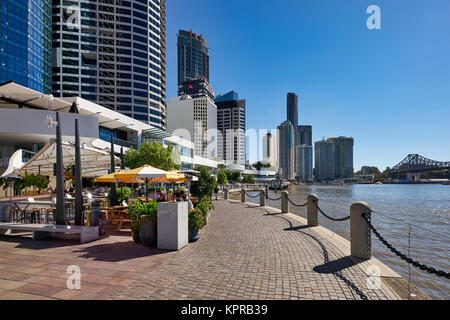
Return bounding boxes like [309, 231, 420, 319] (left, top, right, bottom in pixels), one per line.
[314, 140, 335, 181]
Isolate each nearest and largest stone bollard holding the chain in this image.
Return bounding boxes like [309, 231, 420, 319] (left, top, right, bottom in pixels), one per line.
[350, 201, 372, 259]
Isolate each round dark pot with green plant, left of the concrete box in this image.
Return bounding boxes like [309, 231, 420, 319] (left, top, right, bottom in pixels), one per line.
[128, 200, 158, 246]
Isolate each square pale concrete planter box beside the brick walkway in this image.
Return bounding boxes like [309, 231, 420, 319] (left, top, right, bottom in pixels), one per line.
[157, 201, 189, 250]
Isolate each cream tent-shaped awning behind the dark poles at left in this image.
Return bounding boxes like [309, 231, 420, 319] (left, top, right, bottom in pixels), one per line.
[5, 142, 120, 177]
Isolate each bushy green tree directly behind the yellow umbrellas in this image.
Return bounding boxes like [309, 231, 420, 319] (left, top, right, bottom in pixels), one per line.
[124, 140, 180, 171]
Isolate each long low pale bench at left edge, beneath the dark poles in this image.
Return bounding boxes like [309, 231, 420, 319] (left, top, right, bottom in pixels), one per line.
[0, 222, 99, 243]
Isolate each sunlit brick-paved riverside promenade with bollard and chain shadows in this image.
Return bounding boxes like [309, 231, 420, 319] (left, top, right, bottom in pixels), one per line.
[0, 200, 426, 300]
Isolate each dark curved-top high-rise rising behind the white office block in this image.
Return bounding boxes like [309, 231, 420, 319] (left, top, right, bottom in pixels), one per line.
[177, 30, 209, 86]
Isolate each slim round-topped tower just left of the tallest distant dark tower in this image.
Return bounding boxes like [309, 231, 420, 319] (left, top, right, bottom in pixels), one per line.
[277, 121, 295, 180]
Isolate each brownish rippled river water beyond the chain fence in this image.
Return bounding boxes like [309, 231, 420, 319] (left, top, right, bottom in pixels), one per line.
[244, 184, 450, 299]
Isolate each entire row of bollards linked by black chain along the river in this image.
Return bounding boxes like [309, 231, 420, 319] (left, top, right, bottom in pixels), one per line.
[225, 188, 450, 279]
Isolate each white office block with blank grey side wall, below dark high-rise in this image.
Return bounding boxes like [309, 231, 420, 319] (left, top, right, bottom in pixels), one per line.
[167, 95, 217, 159]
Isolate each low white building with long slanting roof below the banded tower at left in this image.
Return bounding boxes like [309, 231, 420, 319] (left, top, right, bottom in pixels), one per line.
[0, 82, 219, 175]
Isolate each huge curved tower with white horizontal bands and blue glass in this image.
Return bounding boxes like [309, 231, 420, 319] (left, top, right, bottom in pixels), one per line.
[52, 0, 167, 130]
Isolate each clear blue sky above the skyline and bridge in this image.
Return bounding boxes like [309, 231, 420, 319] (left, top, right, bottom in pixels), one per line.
[167, 0, 450, 171]
